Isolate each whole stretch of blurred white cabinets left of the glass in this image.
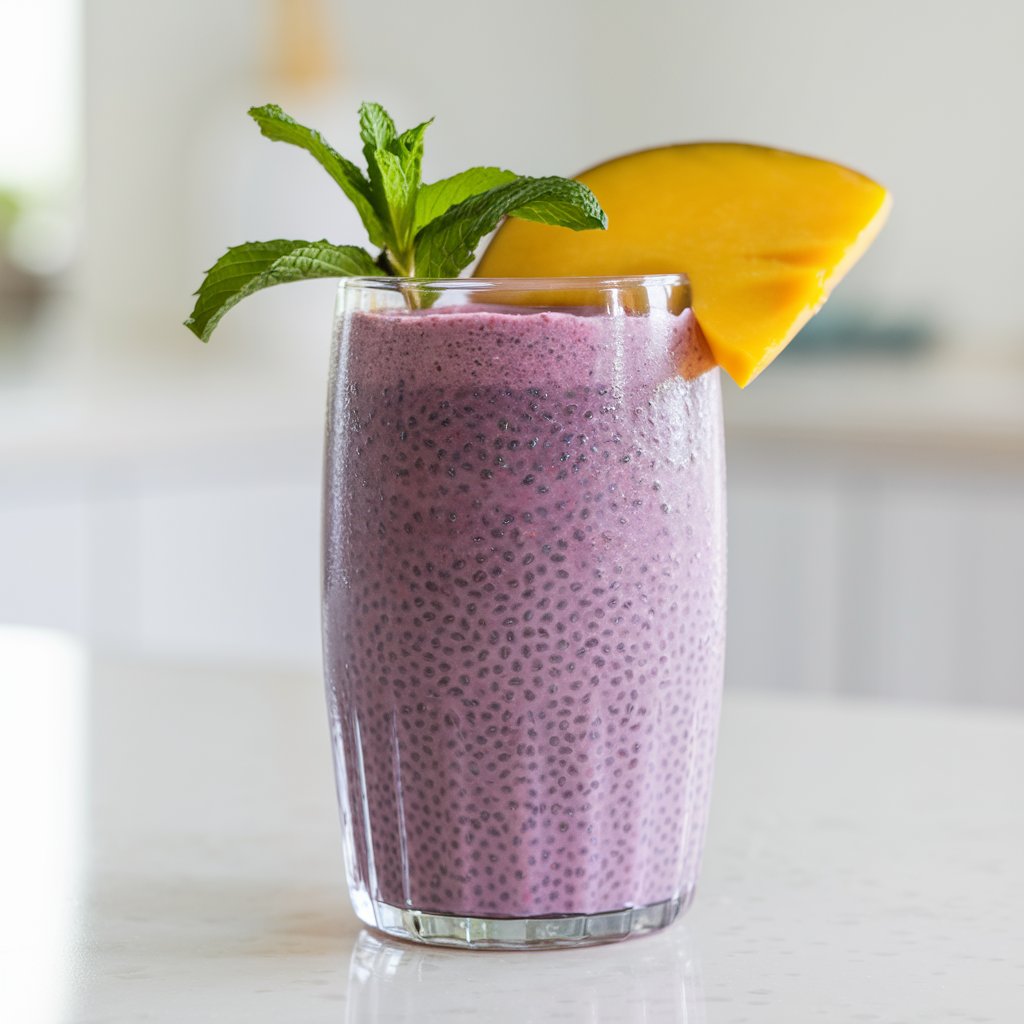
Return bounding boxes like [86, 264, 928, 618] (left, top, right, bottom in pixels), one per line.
[0, 432, 319, 666]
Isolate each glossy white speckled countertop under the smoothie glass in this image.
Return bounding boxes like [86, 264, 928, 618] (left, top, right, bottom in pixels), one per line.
[0, 630, 1024, 1024]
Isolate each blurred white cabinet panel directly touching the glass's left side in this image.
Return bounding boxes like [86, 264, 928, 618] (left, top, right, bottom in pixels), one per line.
[136, 477, 321, 665]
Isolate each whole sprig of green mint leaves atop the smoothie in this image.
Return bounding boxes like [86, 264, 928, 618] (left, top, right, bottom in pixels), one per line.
[185, 103, 607, 341]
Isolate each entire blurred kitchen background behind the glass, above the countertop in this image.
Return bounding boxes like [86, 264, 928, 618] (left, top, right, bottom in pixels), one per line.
[0, 0, 1024, 705]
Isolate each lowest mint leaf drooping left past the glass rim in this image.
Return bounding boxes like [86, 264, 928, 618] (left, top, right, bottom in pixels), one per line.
[185, 239, 383, 341]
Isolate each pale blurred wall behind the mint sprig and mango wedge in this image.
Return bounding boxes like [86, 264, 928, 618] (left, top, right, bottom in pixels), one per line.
[85, 0, 1024, 361]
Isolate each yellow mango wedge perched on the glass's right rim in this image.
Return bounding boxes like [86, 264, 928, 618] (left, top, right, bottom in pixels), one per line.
[475, 142, 891, 387]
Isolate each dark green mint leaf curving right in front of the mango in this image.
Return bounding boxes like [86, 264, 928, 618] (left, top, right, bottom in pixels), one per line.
[415, 177, 608, 278]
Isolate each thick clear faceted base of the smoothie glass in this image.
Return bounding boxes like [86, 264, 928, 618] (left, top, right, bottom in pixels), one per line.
[359, 891, 693, 949]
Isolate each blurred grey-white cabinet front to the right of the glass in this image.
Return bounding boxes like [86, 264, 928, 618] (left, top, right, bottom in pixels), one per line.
[727, 438, 1024, 703]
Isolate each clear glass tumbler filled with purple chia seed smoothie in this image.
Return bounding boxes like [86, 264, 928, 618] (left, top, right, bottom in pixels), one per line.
[323, 275, 725, 948]
